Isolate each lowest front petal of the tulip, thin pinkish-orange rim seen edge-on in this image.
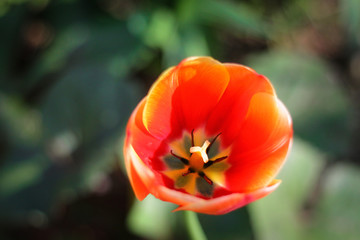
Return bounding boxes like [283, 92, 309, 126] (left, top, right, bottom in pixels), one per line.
[175, 180, 281, 215]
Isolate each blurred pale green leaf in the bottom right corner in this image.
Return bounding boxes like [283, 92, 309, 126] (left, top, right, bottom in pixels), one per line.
[306, 162, 360, 240]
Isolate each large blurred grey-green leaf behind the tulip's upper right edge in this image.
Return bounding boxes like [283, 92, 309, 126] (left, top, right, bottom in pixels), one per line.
[248, 51, 350, 155]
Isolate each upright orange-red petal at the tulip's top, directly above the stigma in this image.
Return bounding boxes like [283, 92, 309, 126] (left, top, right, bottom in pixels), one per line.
[174, 57, 229, 131]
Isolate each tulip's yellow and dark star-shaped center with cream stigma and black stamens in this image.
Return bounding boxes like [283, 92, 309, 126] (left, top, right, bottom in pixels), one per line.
[164, 130, 229, 197]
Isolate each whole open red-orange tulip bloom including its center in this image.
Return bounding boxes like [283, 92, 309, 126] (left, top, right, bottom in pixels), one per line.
[124, 57, 292, 214]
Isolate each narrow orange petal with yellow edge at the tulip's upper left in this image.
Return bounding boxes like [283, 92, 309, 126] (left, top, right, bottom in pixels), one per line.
[143, 67, 178, 140]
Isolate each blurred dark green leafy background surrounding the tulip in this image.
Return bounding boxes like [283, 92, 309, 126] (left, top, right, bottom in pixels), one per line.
[0, 0, 360, 240]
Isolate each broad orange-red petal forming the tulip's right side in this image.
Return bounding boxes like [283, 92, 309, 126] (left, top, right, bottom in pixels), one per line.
[225, 93, 292, 191]
